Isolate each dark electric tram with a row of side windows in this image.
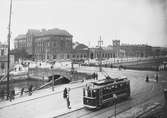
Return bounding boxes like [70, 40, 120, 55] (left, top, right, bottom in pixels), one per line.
[83, 77, 130, 109]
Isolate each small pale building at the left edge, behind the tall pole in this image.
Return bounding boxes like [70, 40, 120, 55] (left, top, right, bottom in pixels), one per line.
[0, 43, 14, 75]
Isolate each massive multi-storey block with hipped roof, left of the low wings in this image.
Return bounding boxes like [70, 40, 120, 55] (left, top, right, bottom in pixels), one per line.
[14, 28, 73, 60]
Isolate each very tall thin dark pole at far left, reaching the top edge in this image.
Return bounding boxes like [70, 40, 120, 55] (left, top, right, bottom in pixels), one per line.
[7, 0, 12, 100]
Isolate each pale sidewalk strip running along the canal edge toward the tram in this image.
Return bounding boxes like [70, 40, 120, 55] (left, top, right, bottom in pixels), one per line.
[0, 80, 94, 109]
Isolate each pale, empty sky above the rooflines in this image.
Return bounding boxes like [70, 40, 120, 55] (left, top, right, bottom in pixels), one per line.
[0, 0, 167, 47]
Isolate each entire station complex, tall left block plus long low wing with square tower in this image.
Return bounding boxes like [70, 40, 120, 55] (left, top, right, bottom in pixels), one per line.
[14, 28, 157, 60]
